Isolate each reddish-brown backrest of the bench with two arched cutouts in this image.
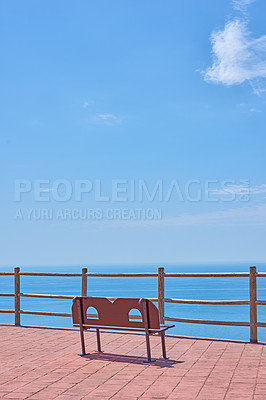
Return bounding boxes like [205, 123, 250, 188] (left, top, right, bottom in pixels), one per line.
[72, 296, 160, 329]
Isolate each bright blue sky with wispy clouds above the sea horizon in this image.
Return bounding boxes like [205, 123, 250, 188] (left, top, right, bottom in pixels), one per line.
[0, 0, 266, 266]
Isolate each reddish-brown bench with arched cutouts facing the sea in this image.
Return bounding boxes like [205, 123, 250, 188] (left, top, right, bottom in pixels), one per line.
[72, 296, 174, 362]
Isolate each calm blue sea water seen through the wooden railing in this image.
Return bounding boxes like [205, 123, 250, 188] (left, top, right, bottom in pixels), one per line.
[0, 263, 266, 342]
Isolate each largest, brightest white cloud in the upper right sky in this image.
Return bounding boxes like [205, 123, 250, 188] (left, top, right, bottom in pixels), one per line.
[204, 0, 266, 95]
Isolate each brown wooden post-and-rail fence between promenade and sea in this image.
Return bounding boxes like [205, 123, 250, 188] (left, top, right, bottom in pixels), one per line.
[0, 267, 266, 343]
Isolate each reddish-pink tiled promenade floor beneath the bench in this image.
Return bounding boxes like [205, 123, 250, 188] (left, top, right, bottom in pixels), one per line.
[0, 325, 266, 400]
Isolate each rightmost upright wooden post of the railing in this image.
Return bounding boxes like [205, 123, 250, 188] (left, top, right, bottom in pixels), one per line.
[249, 267, 257, 343]
